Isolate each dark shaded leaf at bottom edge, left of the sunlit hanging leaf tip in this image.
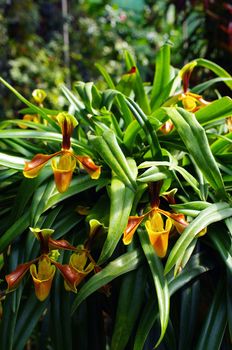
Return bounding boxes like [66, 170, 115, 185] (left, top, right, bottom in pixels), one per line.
[110, 267, 146, 350]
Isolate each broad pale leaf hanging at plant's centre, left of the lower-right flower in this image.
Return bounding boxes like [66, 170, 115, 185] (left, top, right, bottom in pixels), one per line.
[99, 159, 137, 264]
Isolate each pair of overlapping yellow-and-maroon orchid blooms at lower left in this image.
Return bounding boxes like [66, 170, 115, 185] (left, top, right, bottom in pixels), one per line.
[5, 228, 96, 301]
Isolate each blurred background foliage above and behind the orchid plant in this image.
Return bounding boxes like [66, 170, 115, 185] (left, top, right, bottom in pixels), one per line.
[0, 0, 232, 118]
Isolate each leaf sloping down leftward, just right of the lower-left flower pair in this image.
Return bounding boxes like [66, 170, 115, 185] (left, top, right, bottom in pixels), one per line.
[72, 249, 142, 312]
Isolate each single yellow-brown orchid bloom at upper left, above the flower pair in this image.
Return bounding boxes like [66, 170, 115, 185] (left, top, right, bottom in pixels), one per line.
[23, 112, 101, 193]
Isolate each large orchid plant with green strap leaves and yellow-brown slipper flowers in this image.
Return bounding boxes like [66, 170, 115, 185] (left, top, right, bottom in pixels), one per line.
[0, 44, 232, 350]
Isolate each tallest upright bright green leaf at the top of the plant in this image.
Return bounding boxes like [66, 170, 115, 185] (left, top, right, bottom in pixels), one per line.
[151, 44, 170, 111]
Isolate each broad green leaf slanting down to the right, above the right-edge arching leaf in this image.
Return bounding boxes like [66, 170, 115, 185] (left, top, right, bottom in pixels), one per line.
[165, 107, 227, 199]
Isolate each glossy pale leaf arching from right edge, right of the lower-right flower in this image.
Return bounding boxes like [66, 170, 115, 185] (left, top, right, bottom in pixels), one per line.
[165, 203, 232, 273]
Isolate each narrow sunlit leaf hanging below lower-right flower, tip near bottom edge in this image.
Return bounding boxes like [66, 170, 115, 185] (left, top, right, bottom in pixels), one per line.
[139, 231, 170, 347]
